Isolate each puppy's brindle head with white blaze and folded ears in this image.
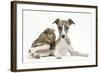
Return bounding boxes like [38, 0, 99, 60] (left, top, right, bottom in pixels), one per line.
[53, 18, 75, 38]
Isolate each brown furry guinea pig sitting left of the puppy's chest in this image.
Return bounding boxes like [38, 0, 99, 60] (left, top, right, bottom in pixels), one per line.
[31, 28, 56, 47]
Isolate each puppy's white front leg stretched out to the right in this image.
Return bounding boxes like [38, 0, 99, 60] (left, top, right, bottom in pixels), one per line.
[68, 45, 88, 57]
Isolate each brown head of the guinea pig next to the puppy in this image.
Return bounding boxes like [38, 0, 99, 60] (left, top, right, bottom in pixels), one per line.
[44, 28, 56, 43]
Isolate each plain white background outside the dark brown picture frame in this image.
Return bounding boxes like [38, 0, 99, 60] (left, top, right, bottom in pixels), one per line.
[0, 0, 100, 73]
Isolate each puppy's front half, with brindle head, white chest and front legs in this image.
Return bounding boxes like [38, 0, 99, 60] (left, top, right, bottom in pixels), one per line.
[53, 19, 88, 59]
